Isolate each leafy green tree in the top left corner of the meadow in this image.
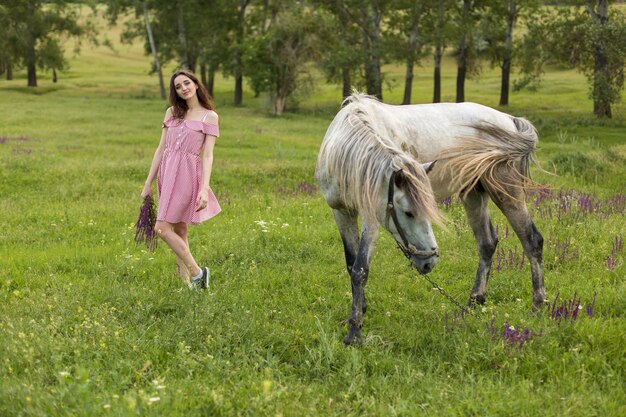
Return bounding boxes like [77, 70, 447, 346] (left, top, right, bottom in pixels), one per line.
[0, 0, 92, 87]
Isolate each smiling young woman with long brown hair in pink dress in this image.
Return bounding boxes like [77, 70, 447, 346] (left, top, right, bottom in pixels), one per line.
[141, 70, 221, 289]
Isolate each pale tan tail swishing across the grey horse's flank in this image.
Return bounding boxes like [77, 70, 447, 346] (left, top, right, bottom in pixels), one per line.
[440, 117, 539, 198]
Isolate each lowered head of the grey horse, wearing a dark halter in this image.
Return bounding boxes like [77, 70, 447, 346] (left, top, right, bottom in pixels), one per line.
[382, 163, 440, 274]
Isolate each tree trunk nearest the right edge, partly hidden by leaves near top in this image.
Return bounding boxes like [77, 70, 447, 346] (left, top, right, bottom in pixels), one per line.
[587, 0, 613, 119]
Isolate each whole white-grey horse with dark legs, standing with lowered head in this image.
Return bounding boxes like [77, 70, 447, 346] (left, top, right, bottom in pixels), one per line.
[315, 94, 546, 344]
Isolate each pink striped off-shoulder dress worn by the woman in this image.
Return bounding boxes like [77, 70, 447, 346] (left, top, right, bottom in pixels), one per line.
[157, 112, 222, 225]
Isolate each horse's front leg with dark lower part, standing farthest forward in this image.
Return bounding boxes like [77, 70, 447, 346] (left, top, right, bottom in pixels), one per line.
[344, 220, 379, 345]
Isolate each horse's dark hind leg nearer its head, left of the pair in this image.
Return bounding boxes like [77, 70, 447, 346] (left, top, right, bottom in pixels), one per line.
[463, 183, 498, 305]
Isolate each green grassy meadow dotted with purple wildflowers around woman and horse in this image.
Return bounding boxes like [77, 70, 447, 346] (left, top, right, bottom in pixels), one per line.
[0, 15, 626, 416]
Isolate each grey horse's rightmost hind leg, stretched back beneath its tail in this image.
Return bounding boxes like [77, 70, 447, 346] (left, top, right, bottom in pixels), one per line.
[491, 190, 547, 310]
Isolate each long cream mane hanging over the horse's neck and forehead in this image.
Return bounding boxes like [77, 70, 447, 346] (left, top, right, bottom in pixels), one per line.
[318, 94, 441, 223]
